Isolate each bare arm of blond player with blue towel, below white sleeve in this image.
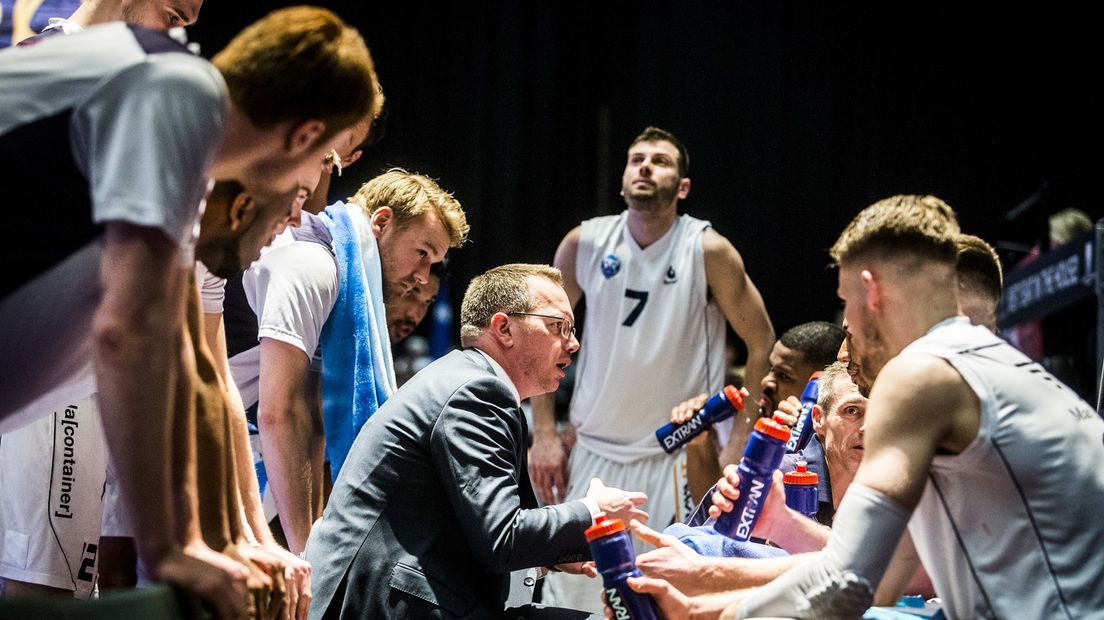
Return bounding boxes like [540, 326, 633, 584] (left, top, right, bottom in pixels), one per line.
[257, 338, 321, 554]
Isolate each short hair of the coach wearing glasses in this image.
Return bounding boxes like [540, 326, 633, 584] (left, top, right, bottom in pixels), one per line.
[460, 263, 563, 343]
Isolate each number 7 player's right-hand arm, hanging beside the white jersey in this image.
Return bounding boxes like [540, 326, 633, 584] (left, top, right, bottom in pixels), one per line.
[701, 228, 774, 467]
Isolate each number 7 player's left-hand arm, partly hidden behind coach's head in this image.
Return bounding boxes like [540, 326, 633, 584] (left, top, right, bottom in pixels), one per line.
[529, 226, 583, 504]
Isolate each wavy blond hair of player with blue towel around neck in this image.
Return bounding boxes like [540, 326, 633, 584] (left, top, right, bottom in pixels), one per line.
[347, 168, 469, 247]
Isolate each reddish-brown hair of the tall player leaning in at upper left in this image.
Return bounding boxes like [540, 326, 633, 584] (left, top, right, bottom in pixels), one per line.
[211, 7, 383, 138]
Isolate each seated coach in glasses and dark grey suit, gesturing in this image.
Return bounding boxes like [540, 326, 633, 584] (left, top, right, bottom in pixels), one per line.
[306, 265, 647, 618]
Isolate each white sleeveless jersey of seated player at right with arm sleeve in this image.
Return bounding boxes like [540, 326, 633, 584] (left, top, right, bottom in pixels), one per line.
[902, 318, 1104, 619]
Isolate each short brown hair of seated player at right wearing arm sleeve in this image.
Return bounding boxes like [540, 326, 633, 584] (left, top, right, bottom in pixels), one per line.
[829, 194, 958, 265]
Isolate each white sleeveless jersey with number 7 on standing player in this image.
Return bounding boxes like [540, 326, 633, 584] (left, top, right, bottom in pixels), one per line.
[571, 211, 724, 462]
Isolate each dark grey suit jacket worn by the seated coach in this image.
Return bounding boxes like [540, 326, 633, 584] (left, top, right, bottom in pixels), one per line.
[307, 350, 591, 619]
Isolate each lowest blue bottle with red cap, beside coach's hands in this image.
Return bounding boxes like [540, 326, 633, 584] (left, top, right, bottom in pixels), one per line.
[586, 514, 658, 620]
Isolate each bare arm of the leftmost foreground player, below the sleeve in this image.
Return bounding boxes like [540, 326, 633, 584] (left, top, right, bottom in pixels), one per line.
[93, 236, 185, 570]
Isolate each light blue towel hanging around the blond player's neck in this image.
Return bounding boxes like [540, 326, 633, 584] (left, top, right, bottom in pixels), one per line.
[320, 201, 395, 480]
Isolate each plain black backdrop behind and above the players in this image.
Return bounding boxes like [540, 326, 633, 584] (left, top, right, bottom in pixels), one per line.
[190, 0, 1104, 353]
